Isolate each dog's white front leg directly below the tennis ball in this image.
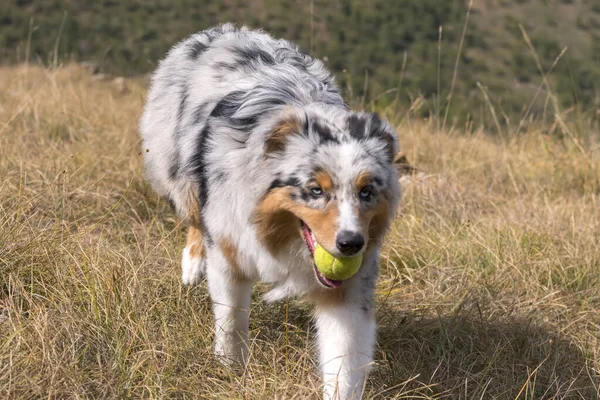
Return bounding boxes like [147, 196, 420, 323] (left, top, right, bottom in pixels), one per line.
[316, 287, 376, 400]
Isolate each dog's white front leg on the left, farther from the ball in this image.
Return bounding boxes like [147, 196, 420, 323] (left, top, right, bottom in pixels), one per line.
[206, 246, 252, 364]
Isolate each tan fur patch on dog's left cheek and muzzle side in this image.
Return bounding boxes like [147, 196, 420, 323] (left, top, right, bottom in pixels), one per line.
[254, 188, 338, 254]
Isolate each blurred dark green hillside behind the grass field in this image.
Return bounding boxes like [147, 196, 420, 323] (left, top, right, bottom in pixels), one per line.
[0, 0, 600, 124]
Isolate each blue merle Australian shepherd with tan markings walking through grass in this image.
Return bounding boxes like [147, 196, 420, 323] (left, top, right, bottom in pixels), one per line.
[140, 24, 401, 399]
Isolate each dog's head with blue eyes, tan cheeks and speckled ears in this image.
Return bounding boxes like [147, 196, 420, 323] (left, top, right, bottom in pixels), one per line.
[255, 109, 400, 287]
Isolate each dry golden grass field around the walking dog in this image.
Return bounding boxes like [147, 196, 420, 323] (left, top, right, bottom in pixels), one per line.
[0, 66, 600, 399]
